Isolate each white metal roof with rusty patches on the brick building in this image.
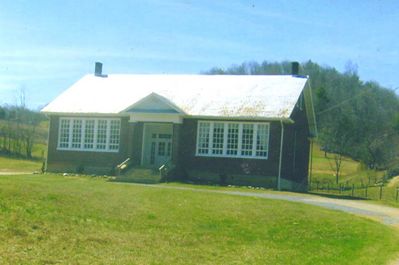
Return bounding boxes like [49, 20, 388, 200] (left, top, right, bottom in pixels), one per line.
[42, 74, 307, 118]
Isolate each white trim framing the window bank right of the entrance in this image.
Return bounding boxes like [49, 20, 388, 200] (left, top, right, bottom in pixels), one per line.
[195, 120, 270, 160]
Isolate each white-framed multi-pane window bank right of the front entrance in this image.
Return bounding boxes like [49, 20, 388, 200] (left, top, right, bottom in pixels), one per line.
[196, 121, 270, 159]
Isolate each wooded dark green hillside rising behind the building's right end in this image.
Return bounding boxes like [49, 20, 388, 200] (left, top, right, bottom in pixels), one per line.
[204, 60, 399, 169]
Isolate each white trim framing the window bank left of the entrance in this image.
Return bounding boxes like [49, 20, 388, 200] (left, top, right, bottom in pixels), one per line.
[57, 117, 122, 153]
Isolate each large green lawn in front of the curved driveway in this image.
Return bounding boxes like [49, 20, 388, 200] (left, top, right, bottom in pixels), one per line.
[0, 174, 399, 265]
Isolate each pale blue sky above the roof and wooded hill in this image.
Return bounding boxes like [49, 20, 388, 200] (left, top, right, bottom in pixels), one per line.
[0, 0, 399, 108]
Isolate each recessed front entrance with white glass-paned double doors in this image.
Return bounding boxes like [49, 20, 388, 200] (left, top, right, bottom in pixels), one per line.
[142, 123, 173, 168]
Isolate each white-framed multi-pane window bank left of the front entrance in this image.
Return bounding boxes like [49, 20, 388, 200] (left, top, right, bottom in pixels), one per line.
[58, 118, 121, 152]
